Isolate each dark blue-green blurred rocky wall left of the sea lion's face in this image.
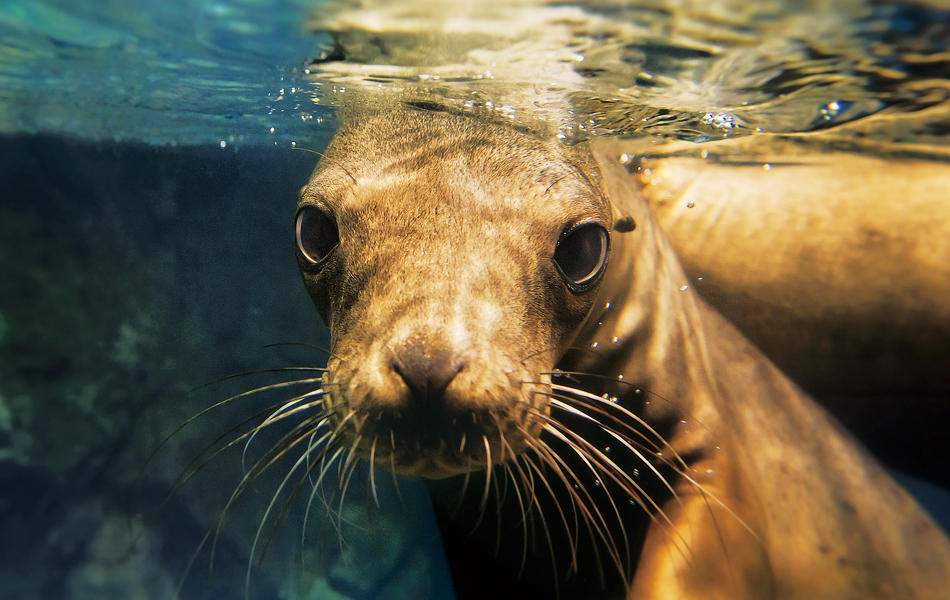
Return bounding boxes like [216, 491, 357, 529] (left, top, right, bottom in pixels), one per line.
[0, 136, 451, 600]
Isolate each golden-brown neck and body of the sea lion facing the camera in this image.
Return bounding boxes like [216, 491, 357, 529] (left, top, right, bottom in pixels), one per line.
[581, 149, 950, 598]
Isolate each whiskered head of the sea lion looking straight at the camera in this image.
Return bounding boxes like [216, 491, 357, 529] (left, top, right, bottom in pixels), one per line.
[295, 110, 611, 478]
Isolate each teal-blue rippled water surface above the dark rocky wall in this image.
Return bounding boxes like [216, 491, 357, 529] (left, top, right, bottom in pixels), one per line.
[0, 0, 323, 145]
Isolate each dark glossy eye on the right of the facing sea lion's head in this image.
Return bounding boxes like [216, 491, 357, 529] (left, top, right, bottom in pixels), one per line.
[554, 222, 610, 293]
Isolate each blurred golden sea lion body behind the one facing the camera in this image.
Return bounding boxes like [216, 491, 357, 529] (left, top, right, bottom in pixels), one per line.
[594, 135, 950, 484]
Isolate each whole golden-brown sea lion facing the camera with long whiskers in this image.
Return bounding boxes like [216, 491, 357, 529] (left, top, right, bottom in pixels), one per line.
[291, 107, 950, 600]
